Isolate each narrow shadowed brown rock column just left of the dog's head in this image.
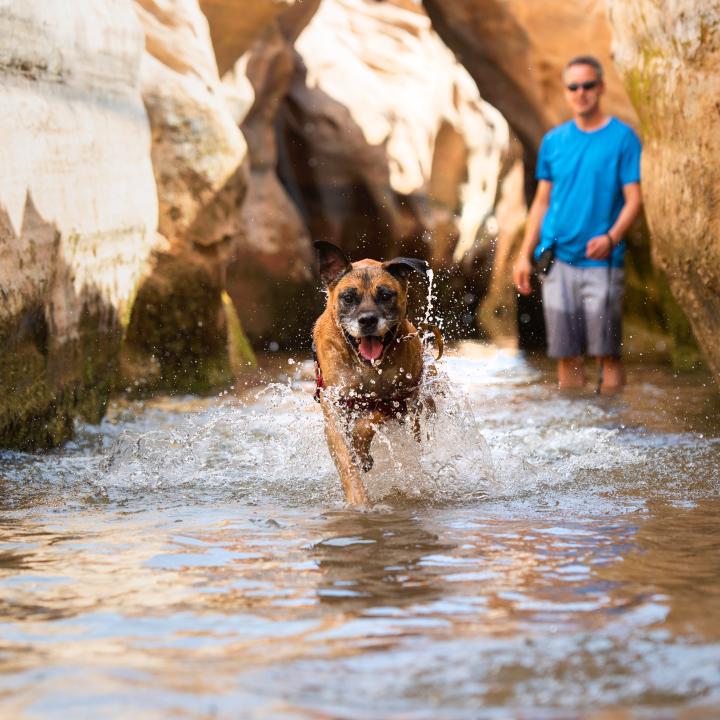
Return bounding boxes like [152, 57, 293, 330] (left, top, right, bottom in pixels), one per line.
[223, 16, 315, 347]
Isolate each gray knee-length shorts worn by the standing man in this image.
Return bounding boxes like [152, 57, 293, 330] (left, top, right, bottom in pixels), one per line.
[542, 260, 625, 358]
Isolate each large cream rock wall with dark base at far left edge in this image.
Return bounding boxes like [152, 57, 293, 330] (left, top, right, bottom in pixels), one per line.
[0, 0, 157, 447]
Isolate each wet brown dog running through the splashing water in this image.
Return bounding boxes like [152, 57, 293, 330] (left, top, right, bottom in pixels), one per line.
[313, 242, 428, 505]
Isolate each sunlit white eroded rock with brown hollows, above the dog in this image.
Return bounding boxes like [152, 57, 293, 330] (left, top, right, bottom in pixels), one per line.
[281, 0, 510, 336]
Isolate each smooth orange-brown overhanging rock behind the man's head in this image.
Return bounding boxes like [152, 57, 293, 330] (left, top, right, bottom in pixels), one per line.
[423, 0, 635, 149]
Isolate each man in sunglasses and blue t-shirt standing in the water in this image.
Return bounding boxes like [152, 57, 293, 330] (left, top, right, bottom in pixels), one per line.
[513, 56, 642, 391]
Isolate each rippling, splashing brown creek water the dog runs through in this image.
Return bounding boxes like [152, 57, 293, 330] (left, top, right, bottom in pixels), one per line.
[0, 346, 720, 720]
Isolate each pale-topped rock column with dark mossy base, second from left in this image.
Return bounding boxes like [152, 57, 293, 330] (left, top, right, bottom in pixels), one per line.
[127, 0, 248, 391]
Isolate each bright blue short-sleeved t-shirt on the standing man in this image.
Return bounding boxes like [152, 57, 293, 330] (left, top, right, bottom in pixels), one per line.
[535, 118, 641, 267]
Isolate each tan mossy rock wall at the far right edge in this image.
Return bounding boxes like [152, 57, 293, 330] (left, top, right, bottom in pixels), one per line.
[608, 0, 720, 381]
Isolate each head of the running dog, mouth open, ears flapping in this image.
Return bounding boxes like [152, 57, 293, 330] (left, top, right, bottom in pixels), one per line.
[315, 241, 428, 364]
